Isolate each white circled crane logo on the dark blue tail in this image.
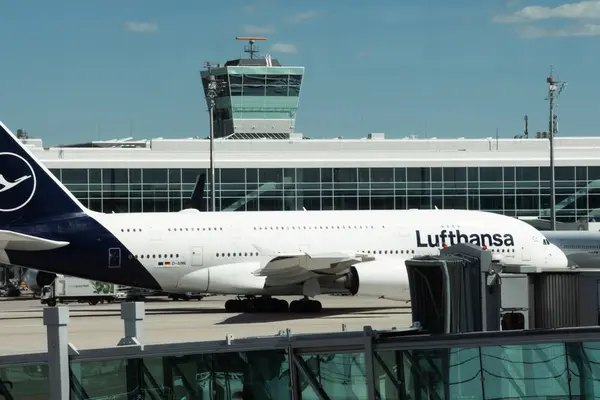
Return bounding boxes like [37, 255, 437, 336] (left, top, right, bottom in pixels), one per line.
[0, 153, 37, 212]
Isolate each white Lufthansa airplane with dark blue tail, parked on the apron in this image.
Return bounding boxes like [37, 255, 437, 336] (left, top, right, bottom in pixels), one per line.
[0, 122, 567, 312]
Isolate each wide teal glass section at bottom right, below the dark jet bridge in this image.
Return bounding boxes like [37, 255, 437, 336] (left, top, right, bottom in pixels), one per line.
[382, 343, 576, 400]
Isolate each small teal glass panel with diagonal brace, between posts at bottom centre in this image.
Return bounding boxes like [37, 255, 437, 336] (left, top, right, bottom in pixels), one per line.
[298, 352, 368, 400]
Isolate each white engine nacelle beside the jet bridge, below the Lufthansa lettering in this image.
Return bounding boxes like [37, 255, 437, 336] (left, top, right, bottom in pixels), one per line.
[338, 259, 410, 301]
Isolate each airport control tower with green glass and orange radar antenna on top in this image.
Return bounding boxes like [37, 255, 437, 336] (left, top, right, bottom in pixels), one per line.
[200, 37, 304, 139]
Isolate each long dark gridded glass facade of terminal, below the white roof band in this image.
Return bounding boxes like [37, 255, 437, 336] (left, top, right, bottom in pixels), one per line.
[52, 167, 600, 222]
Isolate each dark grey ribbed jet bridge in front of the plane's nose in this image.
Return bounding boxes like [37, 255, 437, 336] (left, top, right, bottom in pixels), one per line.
[406, 243, 600, 333]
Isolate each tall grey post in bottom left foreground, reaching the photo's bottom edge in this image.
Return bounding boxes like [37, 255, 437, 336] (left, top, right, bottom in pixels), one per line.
[44, 307, 70, 400]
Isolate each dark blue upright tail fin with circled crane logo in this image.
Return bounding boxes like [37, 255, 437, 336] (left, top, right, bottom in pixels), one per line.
[0, 122, 86, 227]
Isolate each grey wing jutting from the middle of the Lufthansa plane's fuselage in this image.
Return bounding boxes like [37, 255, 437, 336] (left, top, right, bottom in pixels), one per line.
[254, 245, 374, 286]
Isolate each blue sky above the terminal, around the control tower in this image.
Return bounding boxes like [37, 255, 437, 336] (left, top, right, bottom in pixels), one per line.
[0, 0, 600, 144]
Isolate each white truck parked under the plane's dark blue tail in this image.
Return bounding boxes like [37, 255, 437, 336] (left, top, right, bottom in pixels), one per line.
[40, 275, 117, 307]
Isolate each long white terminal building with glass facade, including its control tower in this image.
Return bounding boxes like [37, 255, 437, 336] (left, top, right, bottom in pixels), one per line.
[16, 38, 600, 222]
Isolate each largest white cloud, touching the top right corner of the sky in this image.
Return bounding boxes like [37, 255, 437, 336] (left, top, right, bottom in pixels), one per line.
[493, 0, 600, 23]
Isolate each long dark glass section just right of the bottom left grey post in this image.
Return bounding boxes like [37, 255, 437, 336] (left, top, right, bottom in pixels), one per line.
[71, 350, 290, 399]
